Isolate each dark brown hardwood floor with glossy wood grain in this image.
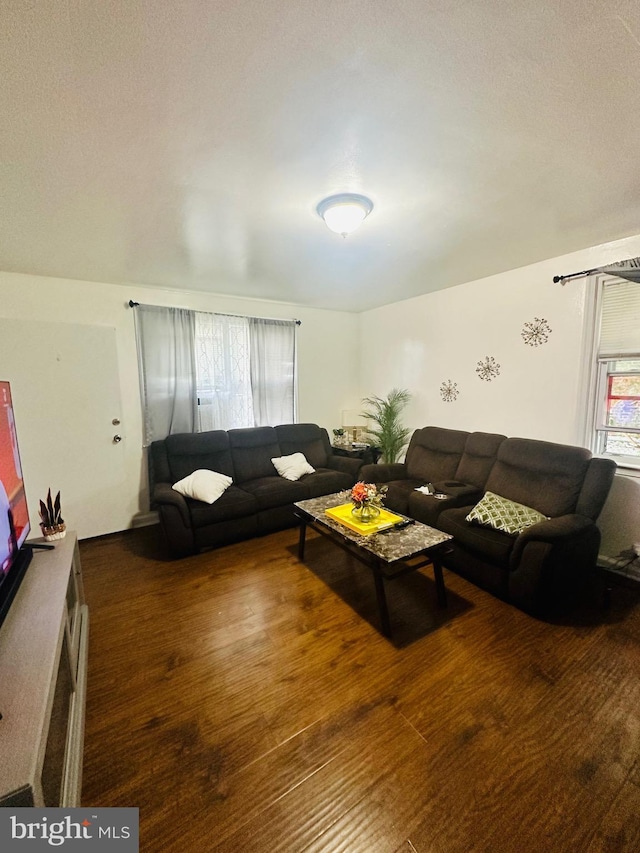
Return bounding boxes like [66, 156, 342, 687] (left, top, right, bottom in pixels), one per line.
[80, 528, 640, 853]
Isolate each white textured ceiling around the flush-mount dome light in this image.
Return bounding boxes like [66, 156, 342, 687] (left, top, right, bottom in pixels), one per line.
[0, 0, 640, 311]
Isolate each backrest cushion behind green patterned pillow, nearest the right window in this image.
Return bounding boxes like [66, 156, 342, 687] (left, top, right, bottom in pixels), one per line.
[486, 438, 591, 516]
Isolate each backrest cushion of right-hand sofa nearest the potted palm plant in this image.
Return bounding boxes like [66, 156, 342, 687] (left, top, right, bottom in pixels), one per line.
[407, 427, 469, 485]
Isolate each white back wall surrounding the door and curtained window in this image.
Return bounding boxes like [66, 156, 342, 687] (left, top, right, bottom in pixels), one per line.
[0, 272, 358, 535]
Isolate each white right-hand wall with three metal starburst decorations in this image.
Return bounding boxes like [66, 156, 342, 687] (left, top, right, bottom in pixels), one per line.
[361, 231, 640, 555]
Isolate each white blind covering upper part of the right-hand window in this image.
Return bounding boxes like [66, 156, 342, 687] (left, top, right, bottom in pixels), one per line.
[598, 281, 640, 359]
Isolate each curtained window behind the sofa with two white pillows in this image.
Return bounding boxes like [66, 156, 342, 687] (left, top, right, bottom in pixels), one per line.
[136, 305, 297, 445]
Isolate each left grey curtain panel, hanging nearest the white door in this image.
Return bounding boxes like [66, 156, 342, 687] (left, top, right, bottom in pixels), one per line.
[135, 305, 197, 446]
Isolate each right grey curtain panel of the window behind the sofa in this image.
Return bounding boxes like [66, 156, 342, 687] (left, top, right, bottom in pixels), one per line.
[249, 317, 296, 426]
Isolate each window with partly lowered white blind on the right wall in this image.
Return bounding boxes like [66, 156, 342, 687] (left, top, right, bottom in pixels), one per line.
[590, 277, 640, 467]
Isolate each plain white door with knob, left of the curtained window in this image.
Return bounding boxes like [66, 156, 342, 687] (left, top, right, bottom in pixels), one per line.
[0, 320, 126, 538]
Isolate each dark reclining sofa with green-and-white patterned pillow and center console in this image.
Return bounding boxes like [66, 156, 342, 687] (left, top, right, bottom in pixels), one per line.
[359, 427, 616, 616]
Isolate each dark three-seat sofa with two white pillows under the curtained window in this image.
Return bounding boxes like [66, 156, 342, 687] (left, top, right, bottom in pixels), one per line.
[149, 424, 362, 557]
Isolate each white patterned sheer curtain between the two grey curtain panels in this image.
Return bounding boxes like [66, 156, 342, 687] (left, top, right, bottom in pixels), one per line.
[195, 312, 254, 432]
